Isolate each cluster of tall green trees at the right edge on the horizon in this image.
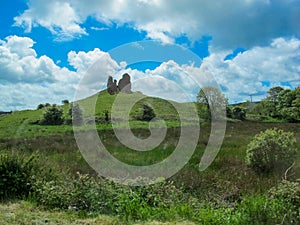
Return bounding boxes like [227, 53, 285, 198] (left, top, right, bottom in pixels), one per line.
[254, 86, 300, 122]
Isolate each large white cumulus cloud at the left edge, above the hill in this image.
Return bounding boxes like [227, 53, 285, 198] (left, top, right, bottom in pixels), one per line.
[0, 36, 80, 110]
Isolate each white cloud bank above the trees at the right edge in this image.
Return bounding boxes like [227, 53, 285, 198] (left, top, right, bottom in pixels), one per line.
[202, 38, 300, 101]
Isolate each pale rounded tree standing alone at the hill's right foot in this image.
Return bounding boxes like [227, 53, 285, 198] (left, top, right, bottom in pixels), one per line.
[197, 86, 228, 119]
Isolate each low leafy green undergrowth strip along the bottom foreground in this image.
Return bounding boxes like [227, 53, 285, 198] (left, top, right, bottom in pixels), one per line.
[29, 175, 299, 225]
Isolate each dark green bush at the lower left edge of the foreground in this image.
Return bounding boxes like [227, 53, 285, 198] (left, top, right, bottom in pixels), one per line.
[0, 154, 37, 199]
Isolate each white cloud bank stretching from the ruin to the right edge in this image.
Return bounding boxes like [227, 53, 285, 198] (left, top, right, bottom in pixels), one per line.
[111, 38, 300, 102]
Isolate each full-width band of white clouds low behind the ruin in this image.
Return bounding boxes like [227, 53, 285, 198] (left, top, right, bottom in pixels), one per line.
[0, 36, 300, 111]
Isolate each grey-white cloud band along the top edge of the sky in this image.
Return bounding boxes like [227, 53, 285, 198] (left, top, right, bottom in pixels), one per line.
[15, 0, 300, 48]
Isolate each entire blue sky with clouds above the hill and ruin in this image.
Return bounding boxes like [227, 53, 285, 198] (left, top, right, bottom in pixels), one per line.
[0, 0, 300, 111]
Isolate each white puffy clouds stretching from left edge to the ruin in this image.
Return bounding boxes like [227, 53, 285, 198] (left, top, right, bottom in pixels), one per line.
[0, 36, 126, 111]
